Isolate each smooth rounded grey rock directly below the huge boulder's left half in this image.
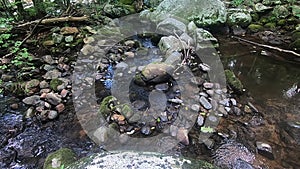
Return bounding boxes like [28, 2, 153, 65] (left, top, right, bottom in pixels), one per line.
[157, 18, 186, 34]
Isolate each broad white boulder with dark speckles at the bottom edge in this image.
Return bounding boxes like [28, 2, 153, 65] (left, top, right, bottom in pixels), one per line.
[66, 151, 215, 169]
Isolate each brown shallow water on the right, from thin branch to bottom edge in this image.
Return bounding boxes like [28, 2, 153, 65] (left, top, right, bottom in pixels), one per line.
[219, 37, 300, 168]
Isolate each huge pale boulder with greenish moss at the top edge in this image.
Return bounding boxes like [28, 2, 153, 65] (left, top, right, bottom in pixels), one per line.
[141, 0, 226, 26]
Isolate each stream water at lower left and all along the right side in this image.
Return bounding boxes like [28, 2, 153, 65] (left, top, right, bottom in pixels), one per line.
[0, 37, 300, 169]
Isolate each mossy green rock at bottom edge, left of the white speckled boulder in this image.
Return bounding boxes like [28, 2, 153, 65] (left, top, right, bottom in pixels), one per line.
[43, 148, 76, 169]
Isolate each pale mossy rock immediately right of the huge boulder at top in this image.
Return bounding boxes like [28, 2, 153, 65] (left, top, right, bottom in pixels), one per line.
[227, 9, 252, 27]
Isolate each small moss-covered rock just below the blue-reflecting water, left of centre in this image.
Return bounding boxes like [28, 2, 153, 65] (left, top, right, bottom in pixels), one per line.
[99, 96, 117, 118]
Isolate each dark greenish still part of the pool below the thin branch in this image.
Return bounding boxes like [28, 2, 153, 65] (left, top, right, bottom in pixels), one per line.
[220, 39, 300, 102]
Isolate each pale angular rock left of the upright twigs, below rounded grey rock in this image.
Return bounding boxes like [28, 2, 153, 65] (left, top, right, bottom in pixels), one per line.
[158, 36, 187, 54]
